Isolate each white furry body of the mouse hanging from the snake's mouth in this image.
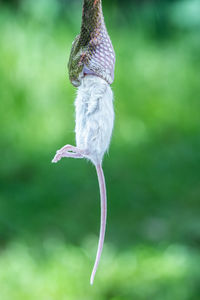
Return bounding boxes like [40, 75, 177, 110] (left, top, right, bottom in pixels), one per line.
[75, 75, 114, 165]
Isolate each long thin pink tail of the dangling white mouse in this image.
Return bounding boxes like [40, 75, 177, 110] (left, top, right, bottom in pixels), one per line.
[90, 164, 107, 285]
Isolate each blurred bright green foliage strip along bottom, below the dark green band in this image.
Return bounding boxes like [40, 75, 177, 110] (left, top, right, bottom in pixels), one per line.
[0, 240, 200, 300]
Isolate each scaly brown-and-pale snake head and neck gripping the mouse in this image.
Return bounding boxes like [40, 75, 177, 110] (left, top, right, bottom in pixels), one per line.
[68, 0, 115, 87]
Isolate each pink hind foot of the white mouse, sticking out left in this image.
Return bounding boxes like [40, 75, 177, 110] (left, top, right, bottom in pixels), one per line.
[52, 145, 84, 163]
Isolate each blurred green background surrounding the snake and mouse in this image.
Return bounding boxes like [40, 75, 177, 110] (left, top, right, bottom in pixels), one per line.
[0, 0, 200, 300]
